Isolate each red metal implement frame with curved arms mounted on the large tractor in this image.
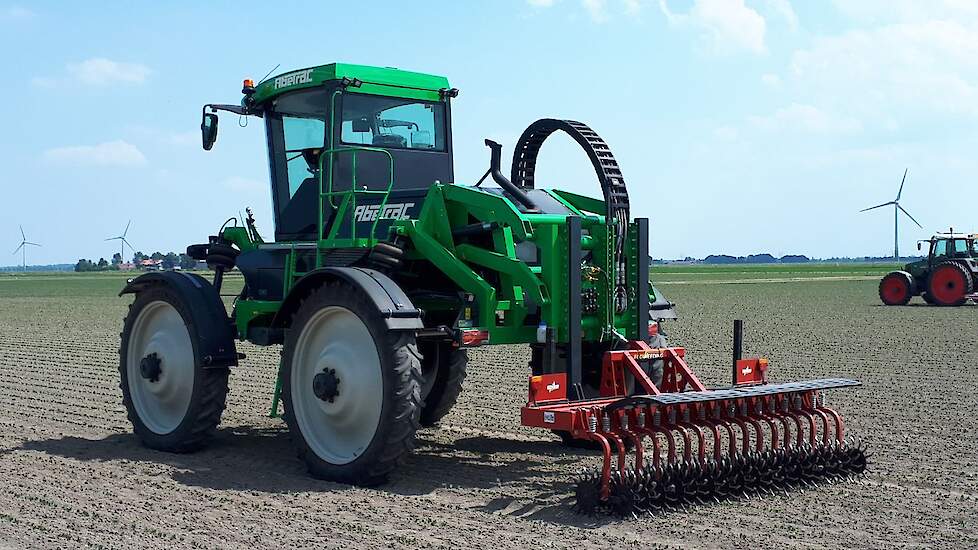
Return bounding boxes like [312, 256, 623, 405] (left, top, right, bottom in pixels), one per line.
[521, 341, 858, 499]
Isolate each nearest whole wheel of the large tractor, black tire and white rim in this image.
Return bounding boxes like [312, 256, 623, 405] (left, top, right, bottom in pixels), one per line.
[282, 282, 422, 486]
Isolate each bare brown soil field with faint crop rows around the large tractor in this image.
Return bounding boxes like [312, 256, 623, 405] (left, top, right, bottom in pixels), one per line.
[0, 270, 978, 550]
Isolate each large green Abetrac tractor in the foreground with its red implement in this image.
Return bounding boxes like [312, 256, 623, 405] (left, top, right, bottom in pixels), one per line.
[120, 63, 865, 511]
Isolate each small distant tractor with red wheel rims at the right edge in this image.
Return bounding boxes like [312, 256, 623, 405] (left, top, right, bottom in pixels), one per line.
[879, 229, 978, 306]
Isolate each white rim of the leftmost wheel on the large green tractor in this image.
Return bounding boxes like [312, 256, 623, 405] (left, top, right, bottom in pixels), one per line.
[126, 301, 195, 435]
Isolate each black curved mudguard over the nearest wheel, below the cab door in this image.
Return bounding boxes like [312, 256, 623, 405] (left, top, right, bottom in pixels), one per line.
[272, 267, 424, 330]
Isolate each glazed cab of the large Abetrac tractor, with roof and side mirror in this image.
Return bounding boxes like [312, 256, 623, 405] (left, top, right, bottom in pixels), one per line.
[201, 63, 458, 242]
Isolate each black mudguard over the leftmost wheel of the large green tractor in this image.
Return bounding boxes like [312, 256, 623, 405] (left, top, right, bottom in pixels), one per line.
[119, 271, 238, 368]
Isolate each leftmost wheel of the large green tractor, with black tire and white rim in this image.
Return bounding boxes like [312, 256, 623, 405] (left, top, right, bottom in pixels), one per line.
[119, 285, 230, 453]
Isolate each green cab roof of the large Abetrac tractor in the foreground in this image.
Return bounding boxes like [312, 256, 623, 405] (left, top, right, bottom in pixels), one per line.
[252, 63, 449, 104]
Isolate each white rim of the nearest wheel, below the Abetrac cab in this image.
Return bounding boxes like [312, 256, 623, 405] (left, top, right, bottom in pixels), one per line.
[290, 306, 384, 464]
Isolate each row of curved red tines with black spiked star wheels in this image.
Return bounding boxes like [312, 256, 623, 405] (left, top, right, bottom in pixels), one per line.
[575, 391, 868, 517]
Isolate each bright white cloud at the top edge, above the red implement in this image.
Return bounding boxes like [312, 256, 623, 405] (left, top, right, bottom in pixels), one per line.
[659, 0, 767, 54]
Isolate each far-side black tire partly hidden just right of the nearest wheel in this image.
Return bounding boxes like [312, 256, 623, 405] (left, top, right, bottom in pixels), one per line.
[420, 342, 469, 427]
